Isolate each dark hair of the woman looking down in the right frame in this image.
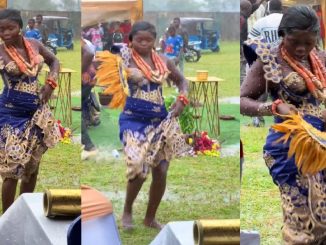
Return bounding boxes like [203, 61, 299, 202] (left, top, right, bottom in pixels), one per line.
[278, 5, 320, 37]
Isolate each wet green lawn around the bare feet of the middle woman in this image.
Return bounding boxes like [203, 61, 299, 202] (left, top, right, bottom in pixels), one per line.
[81, 156, 240, 245]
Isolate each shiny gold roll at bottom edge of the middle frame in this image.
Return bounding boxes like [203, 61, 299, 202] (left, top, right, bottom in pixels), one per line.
[193, 219, 240, 245]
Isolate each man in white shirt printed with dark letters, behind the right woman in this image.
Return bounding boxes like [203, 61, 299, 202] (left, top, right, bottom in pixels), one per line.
[248, 0, 283, 45]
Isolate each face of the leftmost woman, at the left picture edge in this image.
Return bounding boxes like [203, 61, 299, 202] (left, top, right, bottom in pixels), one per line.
[0, 19, 20, 45]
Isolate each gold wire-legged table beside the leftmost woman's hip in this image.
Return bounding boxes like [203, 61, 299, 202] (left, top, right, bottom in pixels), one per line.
[44, 67, 76, 127]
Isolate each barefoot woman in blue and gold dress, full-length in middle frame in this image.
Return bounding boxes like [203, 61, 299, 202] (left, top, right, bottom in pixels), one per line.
[119, 22, 190, 229]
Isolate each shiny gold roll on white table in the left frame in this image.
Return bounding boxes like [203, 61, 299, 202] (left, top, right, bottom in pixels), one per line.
[43, 189, 81, 217]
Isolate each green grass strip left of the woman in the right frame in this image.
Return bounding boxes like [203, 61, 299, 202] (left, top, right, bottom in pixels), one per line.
[240, 117, 282, 245]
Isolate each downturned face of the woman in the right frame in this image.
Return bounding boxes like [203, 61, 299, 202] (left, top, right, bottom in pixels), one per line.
[283, 30, 317, 61]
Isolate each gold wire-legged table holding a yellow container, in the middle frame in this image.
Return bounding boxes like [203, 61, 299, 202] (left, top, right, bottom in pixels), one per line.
[186, 76, 224, 137]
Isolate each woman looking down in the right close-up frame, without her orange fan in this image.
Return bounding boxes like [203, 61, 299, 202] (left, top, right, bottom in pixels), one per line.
[241, 6, 326, 244]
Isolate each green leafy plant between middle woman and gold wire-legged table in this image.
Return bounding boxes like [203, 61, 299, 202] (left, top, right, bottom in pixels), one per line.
[165, 95, 194, 134]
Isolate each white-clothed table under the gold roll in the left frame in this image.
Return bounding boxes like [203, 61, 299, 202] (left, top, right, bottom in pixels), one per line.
[0, 193, 73, 245]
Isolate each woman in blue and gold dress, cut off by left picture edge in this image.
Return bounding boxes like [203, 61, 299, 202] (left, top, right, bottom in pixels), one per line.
[0, 9, 60, 212]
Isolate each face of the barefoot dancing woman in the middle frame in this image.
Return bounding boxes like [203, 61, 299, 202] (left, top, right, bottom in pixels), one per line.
[132, 31, 155, 55]
